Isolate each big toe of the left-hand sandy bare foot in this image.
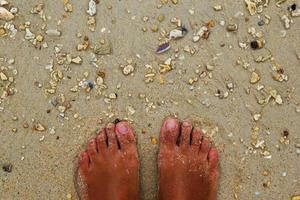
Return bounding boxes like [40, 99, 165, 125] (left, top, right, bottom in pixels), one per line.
[116, 121, 136, 150]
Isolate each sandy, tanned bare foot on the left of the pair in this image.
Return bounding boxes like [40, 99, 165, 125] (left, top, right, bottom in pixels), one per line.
[78, 122, 139, 200]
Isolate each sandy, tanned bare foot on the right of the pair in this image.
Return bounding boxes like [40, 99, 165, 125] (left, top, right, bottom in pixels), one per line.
[158, 118, 218, 200]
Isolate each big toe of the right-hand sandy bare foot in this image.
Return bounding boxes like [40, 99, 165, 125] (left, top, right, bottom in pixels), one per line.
[160, 117, 180, 146]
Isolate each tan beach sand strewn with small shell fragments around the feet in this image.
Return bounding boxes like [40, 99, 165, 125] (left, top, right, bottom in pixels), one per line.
[0, 0, 300, 200]
